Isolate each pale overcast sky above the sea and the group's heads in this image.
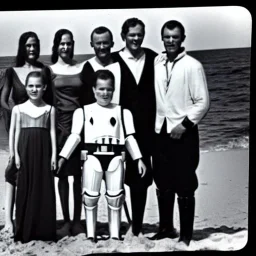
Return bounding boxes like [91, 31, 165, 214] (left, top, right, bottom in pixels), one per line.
[0, 6, 252, 56]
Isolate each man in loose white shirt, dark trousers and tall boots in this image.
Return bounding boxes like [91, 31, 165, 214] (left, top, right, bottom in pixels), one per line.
[151, 20, 209, 246]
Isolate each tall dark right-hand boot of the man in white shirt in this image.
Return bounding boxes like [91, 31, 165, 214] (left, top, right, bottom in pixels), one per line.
[178, 196, 195, 246]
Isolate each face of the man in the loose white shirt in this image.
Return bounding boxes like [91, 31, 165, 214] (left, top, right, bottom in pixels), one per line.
[162, 28, 184, 55]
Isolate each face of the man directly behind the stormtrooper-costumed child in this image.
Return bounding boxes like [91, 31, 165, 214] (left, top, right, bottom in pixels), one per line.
[91, 32, 114, 60]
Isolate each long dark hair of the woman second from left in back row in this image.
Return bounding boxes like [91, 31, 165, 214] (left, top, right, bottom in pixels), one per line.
[51, 28, 74, 64]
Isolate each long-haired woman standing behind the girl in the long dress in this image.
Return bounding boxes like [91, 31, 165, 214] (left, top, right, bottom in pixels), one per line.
[1, 31, 53, 234]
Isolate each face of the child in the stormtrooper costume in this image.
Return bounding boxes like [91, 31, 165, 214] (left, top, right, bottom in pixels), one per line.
[93, 79, 114, 107]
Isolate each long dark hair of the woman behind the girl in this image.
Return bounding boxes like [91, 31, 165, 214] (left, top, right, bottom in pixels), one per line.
[15, 31, 43, 67]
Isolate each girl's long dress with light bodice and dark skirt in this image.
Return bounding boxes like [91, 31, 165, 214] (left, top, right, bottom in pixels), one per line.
[14, 108, 56, 242]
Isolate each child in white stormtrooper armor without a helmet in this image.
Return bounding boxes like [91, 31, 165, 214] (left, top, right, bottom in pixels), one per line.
[59, 70, 146, 241]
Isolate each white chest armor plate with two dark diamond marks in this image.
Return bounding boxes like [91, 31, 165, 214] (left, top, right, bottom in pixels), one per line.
[84, 103, 125, 145]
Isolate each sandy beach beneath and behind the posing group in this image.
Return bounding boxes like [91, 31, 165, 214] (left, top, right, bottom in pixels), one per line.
[0, 130, 249, 255]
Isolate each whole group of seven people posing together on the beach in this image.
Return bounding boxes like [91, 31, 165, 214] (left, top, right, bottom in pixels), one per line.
[1, 18, 209, 248]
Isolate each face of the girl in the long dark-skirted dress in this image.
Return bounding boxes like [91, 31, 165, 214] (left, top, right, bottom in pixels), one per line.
[26, 77, 46, 101]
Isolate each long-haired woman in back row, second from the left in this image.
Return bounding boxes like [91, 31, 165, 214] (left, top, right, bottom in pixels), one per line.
[49, 29, 85, 237]
